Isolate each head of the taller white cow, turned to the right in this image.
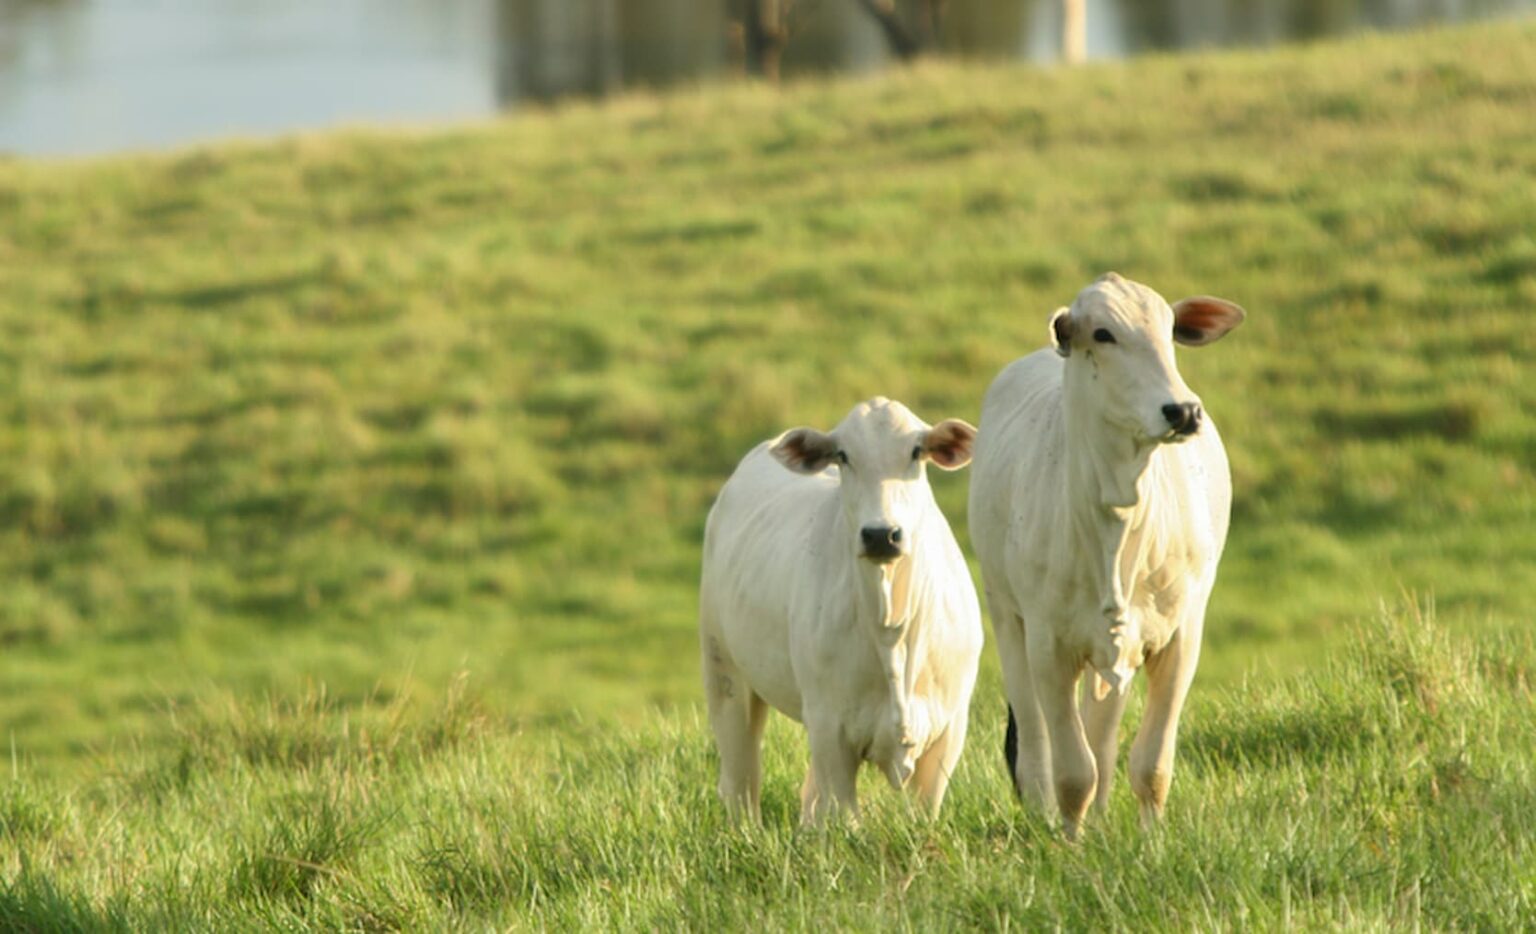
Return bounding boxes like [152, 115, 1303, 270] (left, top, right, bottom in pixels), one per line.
[1051, 272, 1244, 442]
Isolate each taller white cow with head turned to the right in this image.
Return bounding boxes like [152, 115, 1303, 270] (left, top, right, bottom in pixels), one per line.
[969, 273, 1244, 837]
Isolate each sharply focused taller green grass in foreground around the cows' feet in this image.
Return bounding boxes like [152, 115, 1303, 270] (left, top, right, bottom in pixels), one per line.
[0, 604, 1536, 929]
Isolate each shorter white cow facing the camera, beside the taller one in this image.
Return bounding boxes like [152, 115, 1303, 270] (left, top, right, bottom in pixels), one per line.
[699, 398, 982, 823]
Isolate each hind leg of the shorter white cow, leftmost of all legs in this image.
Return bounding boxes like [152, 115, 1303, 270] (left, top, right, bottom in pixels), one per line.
[702, 634, 768, 822]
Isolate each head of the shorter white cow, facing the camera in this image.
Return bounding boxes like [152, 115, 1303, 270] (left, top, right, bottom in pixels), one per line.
[773, 398, 975, 564]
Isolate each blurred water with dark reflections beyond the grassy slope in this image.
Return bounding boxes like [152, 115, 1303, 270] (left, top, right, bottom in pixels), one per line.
[0, 0, 1536, 155]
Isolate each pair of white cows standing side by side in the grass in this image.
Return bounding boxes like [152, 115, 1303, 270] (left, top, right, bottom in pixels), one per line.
[699, 273, 1244, 837]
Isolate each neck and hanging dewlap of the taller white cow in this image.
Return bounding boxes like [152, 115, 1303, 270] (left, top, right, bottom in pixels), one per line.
[1066, 410, 1158, 697]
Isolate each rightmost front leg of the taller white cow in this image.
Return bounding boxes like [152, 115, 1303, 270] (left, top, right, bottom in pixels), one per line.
[1130, 619, 1201, 826]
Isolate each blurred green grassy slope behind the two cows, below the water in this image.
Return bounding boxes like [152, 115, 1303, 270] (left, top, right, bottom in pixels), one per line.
[0, 23, 1536, 768]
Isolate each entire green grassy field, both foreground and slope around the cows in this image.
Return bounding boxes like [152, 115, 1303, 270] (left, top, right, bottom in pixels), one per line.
[0, 23, 1536, 929]
